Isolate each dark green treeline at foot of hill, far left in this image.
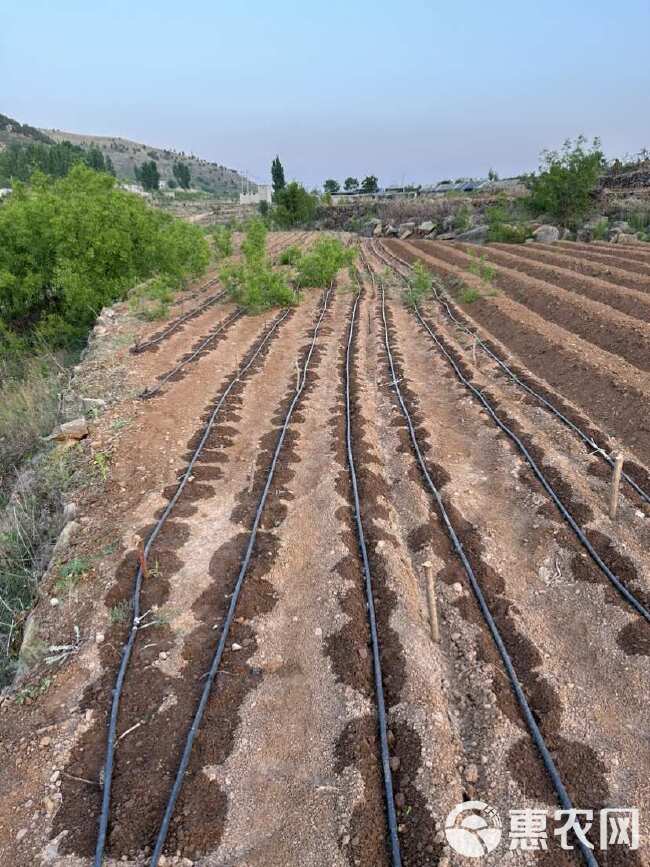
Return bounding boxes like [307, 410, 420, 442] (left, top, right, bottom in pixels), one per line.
[0, 141, 115, 186]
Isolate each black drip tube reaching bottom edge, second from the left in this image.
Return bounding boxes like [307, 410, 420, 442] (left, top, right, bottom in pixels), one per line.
[149, 286, 333, 867]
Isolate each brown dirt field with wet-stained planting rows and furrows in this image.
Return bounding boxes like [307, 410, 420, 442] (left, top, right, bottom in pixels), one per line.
[0, 232, 650, 867]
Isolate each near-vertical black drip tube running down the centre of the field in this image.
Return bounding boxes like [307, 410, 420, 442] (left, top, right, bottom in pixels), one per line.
[345, 288, 402, 867]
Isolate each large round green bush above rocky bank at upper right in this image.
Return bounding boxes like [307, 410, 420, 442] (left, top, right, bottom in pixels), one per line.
[527, 136, 605, 228]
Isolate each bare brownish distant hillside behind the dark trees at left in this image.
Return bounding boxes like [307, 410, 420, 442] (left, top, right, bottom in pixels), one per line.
[38, 129, 247, 197]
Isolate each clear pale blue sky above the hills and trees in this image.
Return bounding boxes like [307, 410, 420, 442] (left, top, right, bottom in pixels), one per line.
[0, 0, 650, 187]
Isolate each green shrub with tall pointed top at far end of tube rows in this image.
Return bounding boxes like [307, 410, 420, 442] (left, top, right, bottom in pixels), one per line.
[219, 220, 296, 313]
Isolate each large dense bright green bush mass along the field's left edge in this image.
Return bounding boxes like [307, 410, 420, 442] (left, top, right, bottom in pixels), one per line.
[0, 165, 209, 347]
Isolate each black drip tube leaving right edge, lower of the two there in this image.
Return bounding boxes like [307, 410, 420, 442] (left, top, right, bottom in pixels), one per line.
[368, 244, 650, 623]
